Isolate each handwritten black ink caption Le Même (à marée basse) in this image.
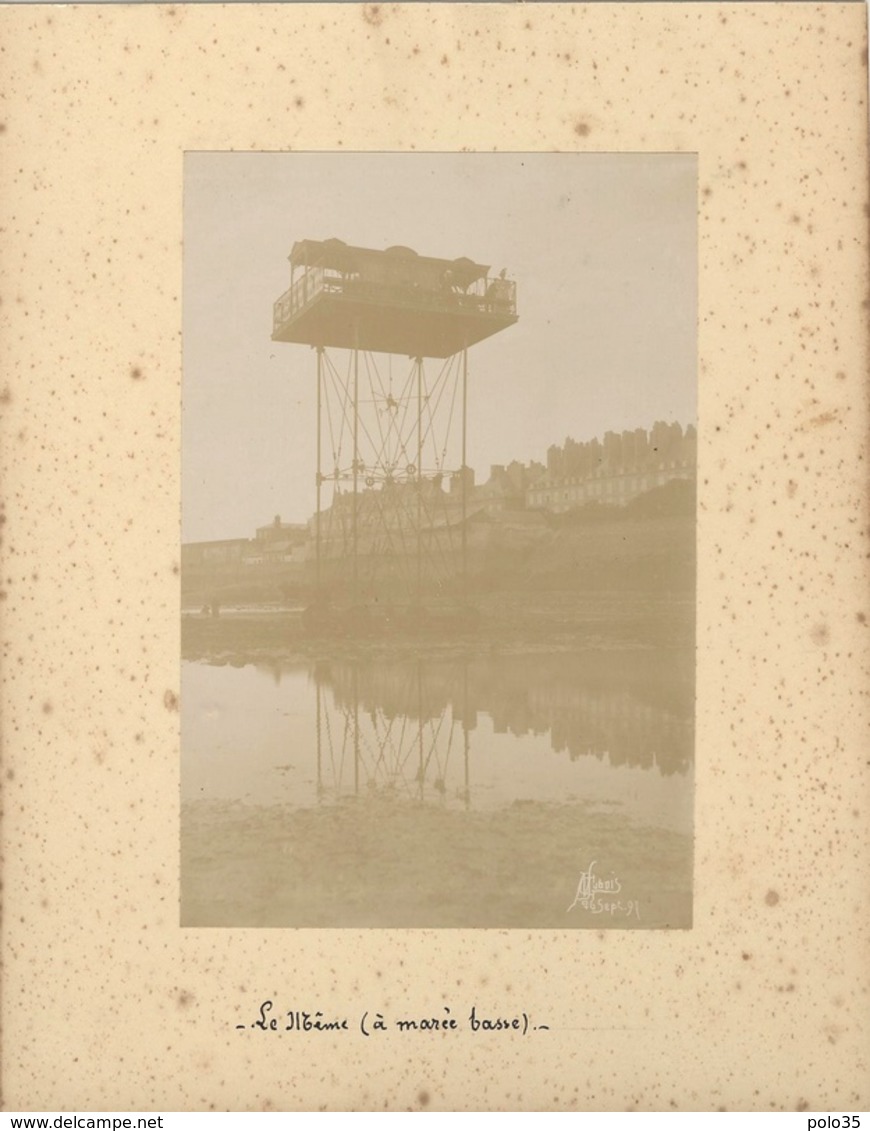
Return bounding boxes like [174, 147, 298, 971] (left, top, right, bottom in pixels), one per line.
[235, 1001, 550, 1037]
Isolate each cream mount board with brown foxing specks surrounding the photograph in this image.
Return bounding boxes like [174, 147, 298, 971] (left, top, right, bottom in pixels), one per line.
[0, 3, 870, 1111]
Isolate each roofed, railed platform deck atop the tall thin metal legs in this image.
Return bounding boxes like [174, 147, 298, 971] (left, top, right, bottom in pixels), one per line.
[272, 240, 517, 357]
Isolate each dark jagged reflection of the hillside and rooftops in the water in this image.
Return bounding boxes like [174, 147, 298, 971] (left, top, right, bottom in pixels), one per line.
[315, 653, 694, 791]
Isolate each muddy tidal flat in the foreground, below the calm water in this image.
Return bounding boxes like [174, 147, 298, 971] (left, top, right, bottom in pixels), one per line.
[182, 797, 691, 930]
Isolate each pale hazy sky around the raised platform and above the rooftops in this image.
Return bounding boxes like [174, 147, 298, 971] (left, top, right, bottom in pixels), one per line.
[182, 153, 697, 542]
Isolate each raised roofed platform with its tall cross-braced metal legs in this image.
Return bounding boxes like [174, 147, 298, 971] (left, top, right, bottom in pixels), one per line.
[272, 240, 517, 605]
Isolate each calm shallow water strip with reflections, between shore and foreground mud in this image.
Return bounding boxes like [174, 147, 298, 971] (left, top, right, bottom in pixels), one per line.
[182, 654, 694, 832]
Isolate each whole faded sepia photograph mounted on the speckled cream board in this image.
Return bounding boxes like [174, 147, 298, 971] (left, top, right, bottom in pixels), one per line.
[181, 152, 698, 931]
